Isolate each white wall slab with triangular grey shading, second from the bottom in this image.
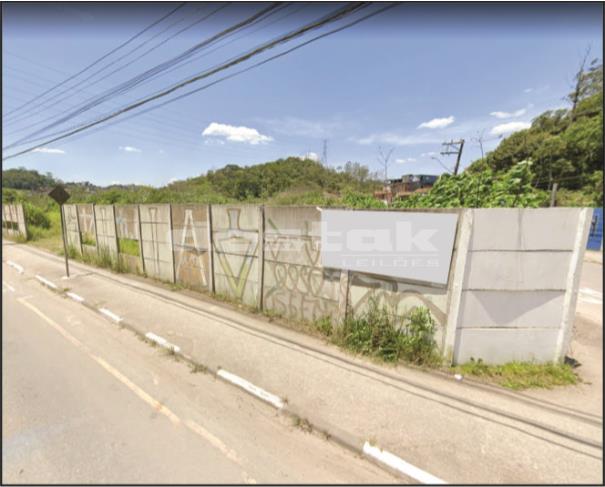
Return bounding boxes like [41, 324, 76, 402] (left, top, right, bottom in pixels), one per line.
[459, 291, 565, 328]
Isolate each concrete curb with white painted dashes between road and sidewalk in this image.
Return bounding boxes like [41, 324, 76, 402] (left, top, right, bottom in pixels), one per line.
[29, 275, 447, 485]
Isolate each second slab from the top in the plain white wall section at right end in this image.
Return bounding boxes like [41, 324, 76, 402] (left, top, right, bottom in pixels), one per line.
[464, 251, 571, 291]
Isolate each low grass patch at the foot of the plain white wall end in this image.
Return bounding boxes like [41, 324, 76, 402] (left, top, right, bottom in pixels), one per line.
[450, 359, 580, 390]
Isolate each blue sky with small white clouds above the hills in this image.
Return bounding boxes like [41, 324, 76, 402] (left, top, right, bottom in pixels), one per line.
[2, 2, 603, 186]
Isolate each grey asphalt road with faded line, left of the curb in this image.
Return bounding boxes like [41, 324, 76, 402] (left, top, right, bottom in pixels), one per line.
[2, 264, 401, 484]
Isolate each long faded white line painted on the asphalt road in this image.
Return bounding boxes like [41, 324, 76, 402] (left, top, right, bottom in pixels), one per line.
[17, 297, 256, 476]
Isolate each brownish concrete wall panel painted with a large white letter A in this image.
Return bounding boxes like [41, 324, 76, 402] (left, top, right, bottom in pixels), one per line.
[172, 205, 212, 290]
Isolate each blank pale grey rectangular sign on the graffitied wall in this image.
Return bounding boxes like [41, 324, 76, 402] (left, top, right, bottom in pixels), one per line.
[321, 210, 458, 285]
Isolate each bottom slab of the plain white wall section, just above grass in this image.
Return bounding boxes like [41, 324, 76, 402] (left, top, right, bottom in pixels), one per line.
[455, 328, 559, 364]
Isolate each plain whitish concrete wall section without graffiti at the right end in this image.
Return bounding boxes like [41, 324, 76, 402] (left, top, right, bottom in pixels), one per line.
[454, 208, 589, 363]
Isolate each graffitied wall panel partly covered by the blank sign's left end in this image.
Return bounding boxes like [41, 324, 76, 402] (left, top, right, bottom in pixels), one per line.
[263, 207, 341, 321]
